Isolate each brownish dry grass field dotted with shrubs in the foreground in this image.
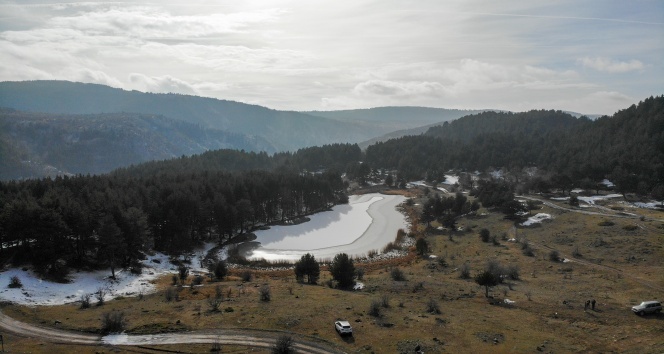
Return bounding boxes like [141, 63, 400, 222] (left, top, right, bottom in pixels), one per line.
[3, 192, 664, 353]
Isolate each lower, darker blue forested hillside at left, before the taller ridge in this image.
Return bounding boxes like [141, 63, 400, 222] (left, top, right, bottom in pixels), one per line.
[0, 109, 275, 180]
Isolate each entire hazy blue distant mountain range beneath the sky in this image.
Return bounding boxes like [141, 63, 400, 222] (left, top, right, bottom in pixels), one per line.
[0, 81, 490, 179]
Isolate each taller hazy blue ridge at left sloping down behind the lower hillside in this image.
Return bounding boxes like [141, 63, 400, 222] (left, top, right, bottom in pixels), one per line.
[0, 81, 389, 151]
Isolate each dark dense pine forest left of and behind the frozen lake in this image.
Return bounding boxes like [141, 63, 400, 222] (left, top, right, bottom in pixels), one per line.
[0, 146, 347, 277]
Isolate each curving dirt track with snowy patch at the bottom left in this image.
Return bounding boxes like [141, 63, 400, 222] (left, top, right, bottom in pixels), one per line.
[0, 311, 343, 354]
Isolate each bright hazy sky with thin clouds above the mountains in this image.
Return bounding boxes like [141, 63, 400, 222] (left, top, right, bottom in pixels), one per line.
[0, 0, 664, 114]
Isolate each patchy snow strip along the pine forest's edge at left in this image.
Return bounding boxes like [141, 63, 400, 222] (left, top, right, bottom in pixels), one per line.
[0, 243, 214, 306]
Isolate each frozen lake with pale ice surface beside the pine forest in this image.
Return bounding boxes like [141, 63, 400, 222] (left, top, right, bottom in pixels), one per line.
[249, 193, 408, 260]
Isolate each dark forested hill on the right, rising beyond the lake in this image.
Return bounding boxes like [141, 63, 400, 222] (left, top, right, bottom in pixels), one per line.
[366, 96, 664, 198]
